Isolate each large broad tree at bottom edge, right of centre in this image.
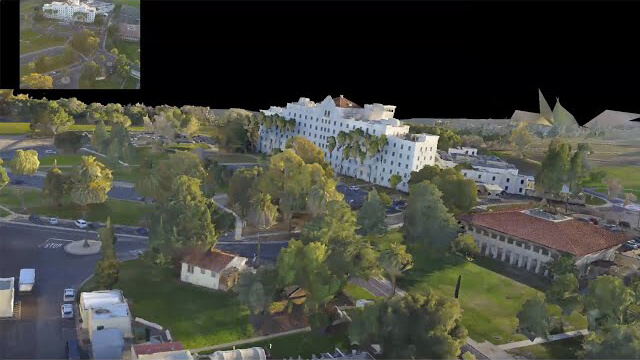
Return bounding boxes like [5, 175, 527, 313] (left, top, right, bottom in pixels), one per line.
[349, 292, 467, 359]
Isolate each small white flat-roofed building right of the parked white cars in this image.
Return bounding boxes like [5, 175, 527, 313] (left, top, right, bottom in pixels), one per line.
[79, 290, 133, 341]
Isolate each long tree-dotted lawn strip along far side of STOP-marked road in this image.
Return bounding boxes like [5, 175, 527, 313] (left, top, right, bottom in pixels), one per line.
[0, 186, 153, 226]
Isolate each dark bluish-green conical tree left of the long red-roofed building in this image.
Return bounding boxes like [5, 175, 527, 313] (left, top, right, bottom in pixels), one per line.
[403, 181, 458, 247]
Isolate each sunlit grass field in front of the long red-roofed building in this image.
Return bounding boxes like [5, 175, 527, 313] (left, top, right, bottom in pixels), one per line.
[399, 249, 585, 344]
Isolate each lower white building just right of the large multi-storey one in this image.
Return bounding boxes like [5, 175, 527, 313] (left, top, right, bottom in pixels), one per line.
[437, 147, 535, 195]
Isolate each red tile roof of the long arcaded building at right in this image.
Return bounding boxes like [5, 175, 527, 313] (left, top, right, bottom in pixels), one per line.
[459, 210, 630, 256]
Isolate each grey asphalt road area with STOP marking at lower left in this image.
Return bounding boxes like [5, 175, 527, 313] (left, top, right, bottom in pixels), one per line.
[0, 223, 146, 359]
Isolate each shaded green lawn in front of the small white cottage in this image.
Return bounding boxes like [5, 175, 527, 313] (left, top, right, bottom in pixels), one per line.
[81, 260, 253, 348]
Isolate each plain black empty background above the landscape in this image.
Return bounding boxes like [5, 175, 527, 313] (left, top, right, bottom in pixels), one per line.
[0, 0, 640, 123]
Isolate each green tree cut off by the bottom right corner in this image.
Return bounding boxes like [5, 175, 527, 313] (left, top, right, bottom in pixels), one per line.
[581, 323, 640, 359]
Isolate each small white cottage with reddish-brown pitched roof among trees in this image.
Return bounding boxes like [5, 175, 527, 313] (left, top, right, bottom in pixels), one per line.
[180, 249, 247, 291]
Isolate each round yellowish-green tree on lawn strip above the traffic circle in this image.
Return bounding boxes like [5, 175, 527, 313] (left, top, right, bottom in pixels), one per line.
[70, 156, 113, 207]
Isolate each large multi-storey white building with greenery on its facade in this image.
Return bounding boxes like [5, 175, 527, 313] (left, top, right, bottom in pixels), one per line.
[258, 95, 438, 191]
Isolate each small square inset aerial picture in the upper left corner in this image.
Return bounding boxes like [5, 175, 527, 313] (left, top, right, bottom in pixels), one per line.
[20, 0, 140, 89]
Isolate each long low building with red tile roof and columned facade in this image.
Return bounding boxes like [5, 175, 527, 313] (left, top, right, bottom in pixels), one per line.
[459, 209, 630, 276]
